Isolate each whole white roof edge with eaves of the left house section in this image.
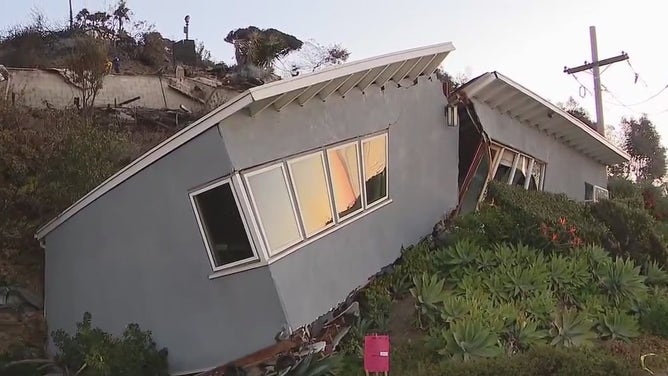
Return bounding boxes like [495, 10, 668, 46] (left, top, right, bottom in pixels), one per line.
[35, 42, 455, 239]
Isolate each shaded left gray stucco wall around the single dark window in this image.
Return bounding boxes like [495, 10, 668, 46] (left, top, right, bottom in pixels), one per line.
[45, 127, 285, 372]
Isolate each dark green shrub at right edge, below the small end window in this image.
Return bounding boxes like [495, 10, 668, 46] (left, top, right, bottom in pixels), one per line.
[591, 200, 668, 265]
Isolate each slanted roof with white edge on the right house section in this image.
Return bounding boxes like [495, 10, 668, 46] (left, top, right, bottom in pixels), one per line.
[458, 72, 631, 165]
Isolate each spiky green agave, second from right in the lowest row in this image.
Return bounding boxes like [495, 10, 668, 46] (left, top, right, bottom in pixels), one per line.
[550, 309, 596, 347]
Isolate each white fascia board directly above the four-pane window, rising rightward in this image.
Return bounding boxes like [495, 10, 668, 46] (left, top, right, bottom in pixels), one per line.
[250, 42, 455, 101]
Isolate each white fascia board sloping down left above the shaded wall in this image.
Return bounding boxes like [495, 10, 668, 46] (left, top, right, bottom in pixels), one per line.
[35, 92, 252, 239]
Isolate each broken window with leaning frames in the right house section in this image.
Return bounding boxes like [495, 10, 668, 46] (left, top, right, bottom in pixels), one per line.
[490, 144, 545, 190]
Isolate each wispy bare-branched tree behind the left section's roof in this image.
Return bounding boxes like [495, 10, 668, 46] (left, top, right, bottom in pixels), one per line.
[276, 40, 350, 77]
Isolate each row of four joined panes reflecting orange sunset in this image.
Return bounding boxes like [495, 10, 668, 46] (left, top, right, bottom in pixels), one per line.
[244, 134, 389, 256]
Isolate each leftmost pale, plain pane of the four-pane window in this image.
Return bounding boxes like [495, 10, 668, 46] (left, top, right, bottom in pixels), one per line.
[246, 164, 302, 254]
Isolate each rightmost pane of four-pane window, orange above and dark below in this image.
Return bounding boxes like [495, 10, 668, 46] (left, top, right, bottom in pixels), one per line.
[362, 135, 387, 205]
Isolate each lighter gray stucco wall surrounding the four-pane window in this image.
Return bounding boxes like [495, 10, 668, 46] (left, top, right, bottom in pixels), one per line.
[221, 77, 458, 327]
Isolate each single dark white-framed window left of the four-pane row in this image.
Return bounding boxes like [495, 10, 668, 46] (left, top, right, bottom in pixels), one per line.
[191, 181, 257, 269]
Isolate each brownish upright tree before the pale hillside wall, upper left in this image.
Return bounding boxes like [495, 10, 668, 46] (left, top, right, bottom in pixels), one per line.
[65, 37, 108, 112]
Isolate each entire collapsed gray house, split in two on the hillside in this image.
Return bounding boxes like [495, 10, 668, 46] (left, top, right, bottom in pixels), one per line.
[36, 43, 628, 375]
